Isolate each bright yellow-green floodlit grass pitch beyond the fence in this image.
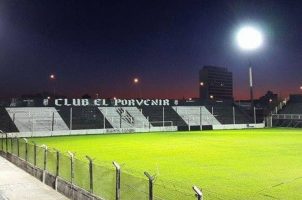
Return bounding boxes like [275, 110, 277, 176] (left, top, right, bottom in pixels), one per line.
[32, 129, 302, 200]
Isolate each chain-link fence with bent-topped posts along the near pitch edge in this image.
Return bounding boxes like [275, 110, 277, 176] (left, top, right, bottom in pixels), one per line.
[0, 133, 202, 200]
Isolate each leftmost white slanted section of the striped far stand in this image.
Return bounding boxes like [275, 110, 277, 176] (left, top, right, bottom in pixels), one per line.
[6, 107, 68, 132]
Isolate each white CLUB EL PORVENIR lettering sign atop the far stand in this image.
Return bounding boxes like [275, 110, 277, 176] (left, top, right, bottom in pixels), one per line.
[53, 99, 172, 106]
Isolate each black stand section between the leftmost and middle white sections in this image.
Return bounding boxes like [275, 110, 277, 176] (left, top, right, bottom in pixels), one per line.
[57, 106, 112, 130]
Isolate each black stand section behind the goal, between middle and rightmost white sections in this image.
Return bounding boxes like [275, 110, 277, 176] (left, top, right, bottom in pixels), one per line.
[140, 106, 187, 126]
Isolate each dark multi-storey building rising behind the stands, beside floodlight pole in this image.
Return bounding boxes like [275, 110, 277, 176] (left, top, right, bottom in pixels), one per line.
[199, 66, 233, 100]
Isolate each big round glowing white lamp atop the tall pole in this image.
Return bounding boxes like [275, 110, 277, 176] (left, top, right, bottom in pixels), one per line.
[236, 26, 263, 51]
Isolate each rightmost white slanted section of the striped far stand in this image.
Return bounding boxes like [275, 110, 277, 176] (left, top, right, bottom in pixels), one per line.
[173, 106, 220, 126]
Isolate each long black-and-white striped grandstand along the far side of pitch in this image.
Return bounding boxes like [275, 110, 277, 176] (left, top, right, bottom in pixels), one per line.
[0, 99, 262, 138]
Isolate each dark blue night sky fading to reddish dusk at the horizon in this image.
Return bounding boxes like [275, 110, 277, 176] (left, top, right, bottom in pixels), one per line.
[0, 0, 302, 99]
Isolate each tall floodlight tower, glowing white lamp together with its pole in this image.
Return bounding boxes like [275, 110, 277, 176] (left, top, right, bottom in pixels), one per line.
[236, 26, 263, 115]
